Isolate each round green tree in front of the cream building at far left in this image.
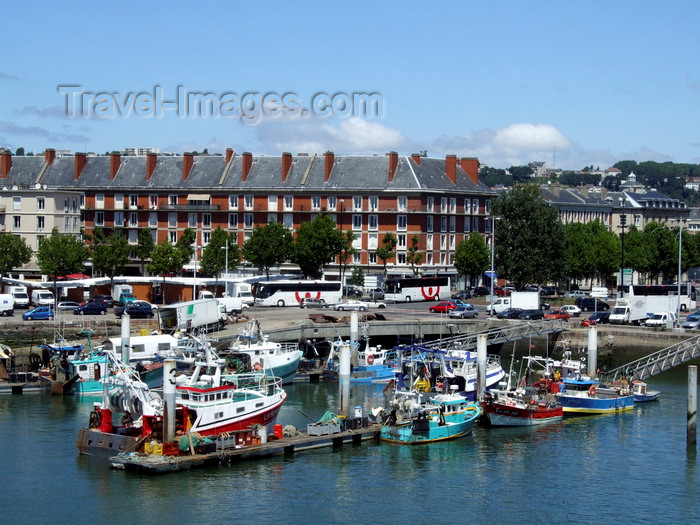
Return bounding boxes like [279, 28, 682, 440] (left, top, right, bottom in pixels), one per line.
[36, 228, 90, 297]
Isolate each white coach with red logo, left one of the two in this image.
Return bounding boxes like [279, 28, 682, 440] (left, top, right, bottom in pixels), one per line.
[253, 280, 343, 306]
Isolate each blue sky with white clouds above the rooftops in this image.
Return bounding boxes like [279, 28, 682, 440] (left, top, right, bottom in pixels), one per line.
[0, 0, 700, 169]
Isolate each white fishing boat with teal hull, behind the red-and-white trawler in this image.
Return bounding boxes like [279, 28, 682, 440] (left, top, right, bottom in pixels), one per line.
[227, 319, 304, 385]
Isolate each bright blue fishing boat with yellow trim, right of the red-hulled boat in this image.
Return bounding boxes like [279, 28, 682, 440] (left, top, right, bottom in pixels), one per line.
[557, 376, 634, 416]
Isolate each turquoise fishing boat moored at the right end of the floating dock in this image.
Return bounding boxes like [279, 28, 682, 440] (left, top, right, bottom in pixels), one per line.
[379, 386, 481, 445]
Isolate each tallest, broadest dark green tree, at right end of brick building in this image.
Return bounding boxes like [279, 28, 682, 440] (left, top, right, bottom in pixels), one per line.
[492, 184, 566, 288]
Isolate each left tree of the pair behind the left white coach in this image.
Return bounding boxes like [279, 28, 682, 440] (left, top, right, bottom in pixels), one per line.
[243, 221, 293, 279]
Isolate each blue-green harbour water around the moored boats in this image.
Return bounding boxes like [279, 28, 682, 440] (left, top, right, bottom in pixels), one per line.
[0, 366, 700, 524]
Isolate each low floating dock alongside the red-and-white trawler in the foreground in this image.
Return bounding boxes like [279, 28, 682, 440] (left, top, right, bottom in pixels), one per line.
[109, 424, 381, 474]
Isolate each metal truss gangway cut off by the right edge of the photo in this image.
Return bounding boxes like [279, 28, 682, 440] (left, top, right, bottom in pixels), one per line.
[601, 335, 700, 381]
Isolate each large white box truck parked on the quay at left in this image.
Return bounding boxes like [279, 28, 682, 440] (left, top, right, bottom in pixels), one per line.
[158, 299, 228, 332]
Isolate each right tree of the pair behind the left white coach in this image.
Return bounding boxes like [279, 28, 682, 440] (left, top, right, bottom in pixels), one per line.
[293, 215, 346, 279]
